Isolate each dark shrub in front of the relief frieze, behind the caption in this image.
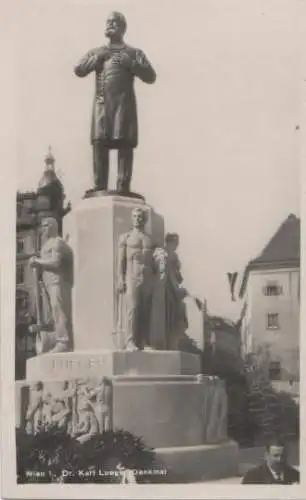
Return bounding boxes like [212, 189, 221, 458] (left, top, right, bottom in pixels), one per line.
[16, 426, 158, 483]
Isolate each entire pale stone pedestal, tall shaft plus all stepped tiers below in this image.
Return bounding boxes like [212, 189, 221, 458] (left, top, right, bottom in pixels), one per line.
[16, 196, 238, 481]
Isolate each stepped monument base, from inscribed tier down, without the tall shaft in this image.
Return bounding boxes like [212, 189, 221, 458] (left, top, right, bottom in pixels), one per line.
[16, 351, 238, 481]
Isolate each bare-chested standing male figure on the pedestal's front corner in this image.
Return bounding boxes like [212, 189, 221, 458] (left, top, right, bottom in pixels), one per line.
[118, 208, 153, 350]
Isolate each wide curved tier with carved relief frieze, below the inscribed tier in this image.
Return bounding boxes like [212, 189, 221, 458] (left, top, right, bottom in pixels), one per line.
[16, 374, 227, 448]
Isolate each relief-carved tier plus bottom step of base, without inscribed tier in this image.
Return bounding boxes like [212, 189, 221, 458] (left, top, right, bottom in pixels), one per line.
[16, 375, 238, 481]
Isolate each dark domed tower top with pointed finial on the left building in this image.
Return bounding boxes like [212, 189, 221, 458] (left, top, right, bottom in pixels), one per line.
[37, 146, 68, 232]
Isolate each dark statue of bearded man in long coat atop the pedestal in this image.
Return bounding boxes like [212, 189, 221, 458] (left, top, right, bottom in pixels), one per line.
[75, 12, 156, 195]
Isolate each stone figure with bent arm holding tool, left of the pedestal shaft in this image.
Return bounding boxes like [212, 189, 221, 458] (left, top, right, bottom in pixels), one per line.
[29, 217, 73, 352]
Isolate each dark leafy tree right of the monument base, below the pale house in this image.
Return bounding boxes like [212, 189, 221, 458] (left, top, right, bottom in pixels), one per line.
[202, 346, 299, 446]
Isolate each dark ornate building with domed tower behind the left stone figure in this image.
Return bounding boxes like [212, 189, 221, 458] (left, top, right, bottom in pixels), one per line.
[15, 150, 70, 380]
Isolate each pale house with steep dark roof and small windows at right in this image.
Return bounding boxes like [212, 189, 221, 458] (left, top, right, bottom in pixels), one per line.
[240, 215, 300, 380]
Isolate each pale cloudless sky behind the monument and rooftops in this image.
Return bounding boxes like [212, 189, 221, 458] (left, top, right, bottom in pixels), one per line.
[10, 0, 301, 344]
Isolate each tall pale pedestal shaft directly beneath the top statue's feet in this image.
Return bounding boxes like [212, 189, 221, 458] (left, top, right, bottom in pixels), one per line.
[63, 196, 164, 351]
